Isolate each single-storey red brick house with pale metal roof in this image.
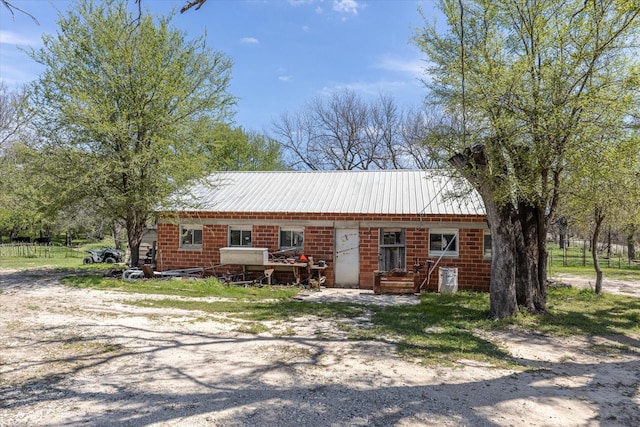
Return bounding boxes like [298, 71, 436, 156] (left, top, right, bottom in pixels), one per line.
[156, 170, 491, 290]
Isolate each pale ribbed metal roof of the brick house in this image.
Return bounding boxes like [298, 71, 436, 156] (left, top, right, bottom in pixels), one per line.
[181, 170, 485, 215]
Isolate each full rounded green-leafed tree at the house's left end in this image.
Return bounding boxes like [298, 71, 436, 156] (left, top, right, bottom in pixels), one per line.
[25, 0, 234, 265]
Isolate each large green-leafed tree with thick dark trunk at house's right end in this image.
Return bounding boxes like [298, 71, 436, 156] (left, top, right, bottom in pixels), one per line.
[414, 0, 640, 318]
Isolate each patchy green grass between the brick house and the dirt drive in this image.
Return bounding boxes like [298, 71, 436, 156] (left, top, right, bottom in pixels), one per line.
[36, 275, 640, 368]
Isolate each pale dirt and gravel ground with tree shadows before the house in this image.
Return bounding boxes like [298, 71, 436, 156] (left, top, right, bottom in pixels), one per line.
[0, 270, 640, 426]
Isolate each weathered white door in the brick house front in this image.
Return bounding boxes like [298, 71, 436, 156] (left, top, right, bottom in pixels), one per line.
[334, 228, 360, 287]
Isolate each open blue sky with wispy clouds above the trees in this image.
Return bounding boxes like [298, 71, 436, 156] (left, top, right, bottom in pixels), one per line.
[0, 0, 442, 133]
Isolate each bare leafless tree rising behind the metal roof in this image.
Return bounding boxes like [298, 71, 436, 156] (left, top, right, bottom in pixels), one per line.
[273, 90, 439, 170]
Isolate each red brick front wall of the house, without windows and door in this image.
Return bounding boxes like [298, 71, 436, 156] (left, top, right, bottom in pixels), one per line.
[157, 212, 491, 291]
